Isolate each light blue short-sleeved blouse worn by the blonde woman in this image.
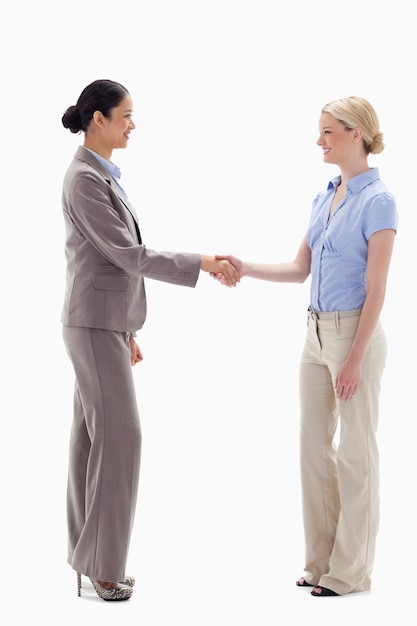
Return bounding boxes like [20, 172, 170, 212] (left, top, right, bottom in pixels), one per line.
[307, 168, 398, 312]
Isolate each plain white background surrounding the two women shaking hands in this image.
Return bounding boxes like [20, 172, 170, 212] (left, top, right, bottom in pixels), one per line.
[0, 0, 417, 626]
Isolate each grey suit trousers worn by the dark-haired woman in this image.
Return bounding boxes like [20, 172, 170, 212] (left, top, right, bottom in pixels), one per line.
[63, 326, 141, 582]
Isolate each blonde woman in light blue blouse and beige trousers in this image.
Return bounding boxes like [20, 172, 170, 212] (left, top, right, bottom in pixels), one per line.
[216, 96, 398, 597]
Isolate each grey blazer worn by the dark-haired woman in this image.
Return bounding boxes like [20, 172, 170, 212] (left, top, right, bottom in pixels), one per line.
[61, 146, 201, 332]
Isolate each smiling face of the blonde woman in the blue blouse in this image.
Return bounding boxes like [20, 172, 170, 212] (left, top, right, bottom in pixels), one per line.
[317, 113, 358, 165]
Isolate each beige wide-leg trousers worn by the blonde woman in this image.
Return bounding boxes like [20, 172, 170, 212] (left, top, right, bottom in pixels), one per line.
[300, 312, 387, 595]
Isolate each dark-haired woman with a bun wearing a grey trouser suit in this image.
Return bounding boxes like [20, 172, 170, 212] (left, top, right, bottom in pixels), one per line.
[61, 80, 237, 600]
